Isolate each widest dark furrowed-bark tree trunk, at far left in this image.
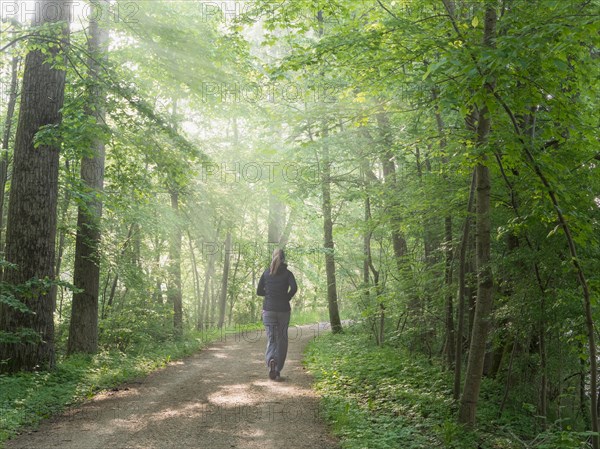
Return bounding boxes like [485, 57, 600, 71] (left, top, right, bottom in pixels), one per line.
[0, 0, 70, 372]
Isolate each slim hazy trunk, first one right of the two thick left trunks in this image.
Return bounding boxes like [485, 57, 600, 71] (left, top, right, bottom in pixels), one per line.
[167, 190, 183, 337]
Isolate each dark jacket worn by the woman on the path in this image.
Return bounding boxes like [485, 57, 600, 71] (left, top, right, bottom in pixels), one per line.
[256, 263, 298, 312]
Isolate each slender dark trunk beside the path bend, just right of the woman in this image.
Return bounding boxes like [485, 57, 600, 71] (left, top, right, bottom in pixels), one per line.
[321, 126, 342, 333]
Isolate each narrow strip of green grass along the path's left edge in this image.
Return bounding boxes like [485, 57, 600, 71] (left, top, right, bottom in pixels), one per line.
[0, 325, 259, 448]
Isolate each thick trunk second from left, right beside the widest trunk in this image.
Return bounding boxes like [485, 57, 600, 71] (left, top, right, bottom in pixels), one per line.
[67, 2, 108, 354]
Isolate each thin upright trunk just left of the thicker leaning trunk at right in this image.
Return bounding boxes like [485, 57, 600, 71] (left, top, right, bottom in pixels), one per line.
[454, 173, 475, 400]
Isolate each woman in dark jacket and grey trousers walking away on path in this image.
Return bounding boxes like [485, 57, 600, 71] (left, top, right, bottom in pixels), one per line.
[256, 249, 298, 381]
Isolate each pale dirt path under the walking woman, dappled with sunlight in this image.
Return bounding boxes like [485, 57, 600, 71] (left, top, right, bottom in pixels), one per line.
[6, 325, 339, 449]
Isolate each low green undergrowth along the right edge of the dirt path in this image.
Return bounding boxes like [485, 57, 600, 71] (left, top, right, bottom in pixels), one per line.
[305, 327, 585, 449]
